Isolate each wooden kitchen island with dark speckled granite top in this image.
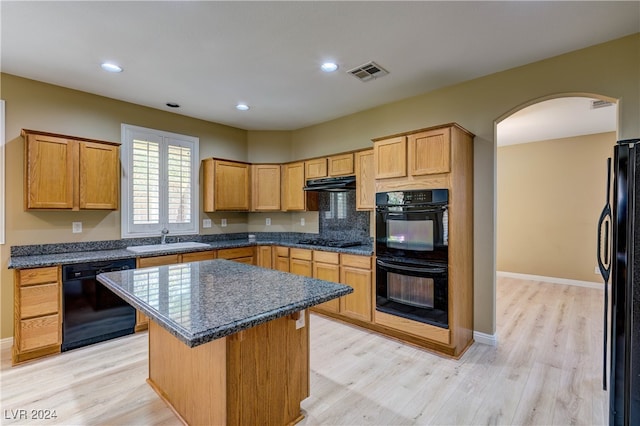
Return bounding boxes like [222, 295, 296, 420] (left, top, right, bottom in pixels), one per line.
[98, 260, 353, 425]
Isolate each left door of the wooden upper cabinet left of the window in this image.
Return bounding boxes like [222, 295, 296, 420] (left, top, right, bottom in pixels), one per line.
[25, 134, 78, 209]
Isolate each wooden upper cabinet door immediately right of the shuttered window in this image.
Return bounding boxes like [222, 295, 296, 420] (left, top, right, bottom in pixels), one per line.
[213, 160, 250, 211]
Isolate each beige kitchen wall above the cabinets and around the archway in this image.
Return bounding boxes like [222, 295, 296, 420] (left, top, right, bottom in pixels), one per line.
[0, 34, 640, 337]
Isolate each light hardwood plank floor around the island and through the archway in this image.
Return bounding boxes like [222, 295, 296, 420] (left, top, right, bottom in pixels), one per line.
[0, 278, 607, 425]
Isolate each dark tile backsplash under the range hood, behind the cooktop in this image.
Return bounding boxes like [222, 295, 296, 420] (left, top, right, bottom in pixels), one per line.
[318, 191, 370, 241]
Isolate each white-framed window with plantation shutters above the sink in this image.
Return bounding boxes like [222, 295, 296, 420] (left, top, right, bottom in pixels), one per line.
[121, 124, 199, 238]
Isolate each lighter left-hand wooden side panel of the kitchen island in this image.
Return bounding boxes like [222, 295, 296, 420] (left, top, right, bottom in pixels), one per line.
[148, 321, 227, 425]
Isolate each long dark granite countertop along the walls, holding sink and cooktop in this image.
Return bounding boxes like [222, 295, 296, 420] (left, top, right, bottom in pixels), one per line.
[8, 238, 373, 269]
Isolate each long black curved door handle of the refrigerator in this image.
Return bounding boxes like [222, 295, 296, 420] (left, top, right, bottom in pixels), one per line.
[597, 158, 612, 390]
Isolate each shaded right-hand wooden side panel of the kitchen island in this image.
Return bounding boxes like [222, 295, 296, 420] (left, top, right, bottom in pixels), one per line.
[227, 310, 309, 425]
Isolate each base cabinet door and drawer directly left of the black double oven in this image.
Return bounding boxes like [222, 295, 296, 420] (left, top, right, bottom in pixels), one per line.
[340, 255, 372, 322]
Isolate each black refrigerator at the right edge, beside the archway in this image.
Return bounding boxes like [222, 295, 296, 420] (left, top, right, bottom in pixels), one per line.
[598, 139, 640, 426]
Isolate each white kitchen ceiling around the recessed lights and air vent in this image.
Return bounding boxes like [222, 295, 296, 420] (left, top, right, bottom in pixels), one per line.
[0, 0, 640, 139]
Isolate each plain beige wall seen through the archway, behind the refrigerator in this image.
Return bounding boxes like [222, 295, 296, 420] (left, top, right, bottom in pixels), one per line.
[496, 132, 616, 282]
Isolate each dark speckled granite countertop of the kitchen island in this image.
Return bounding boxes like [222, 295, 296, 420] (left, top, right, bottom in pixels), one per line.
[98, 259, 353, 347]
